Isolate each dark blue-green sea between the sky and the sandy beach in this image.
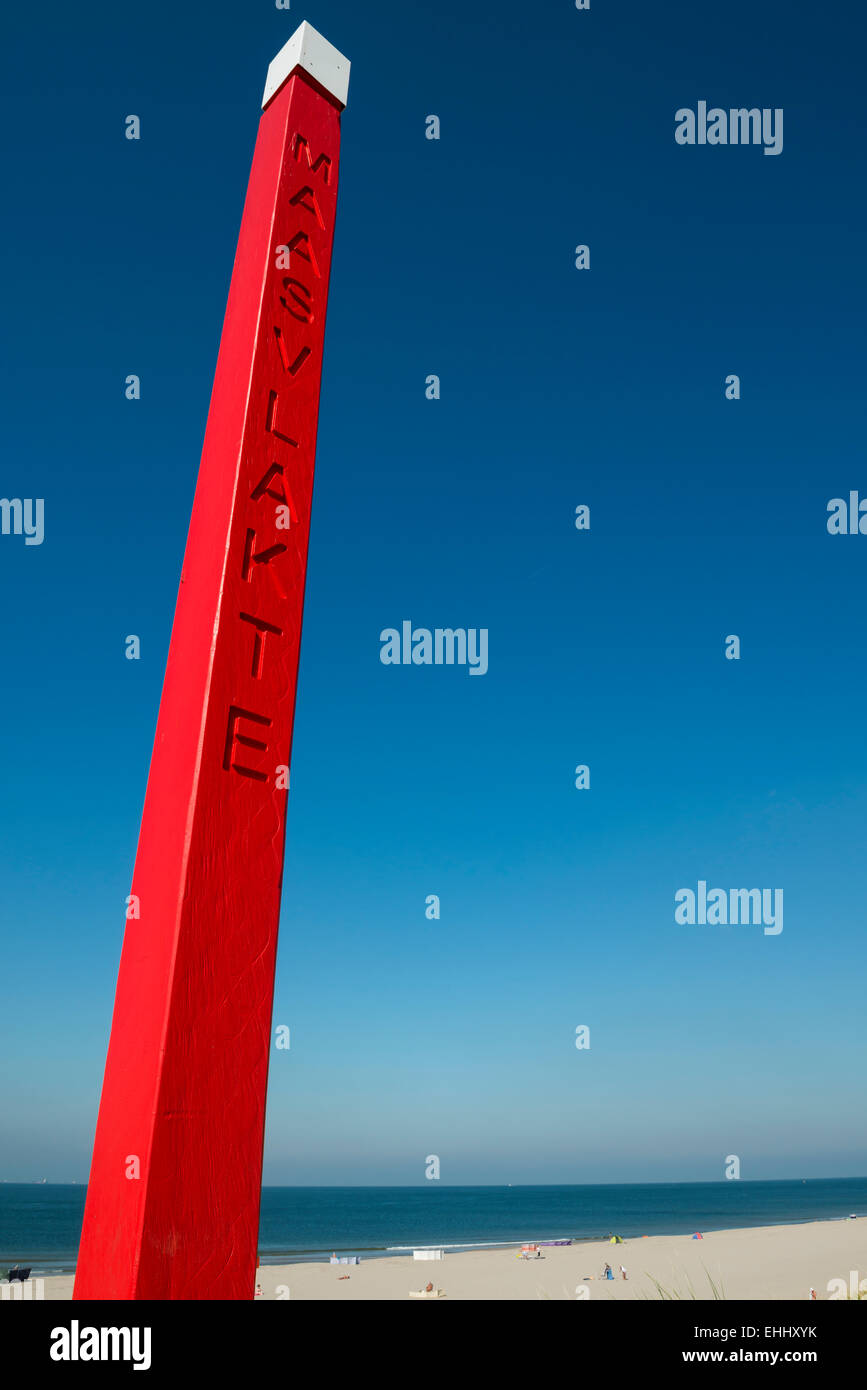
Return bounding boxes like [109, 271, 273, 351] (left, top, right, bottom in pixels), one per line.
[0, 1177, 867, 1276]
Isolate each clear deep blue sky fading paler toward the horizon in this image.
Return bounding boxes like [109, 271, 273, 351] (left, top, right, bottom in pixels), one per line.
[0, 0, 867, 1183]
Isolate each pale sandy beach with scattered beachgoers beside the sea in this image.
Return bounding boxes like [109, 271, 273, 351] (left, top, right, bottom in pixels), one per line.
[32, 1219, 867, 1302]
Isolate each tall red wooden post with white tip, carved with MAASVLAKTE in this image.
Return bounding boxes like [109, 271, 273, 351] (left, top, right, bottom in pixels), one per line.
[74, 24, 349, 1298]
